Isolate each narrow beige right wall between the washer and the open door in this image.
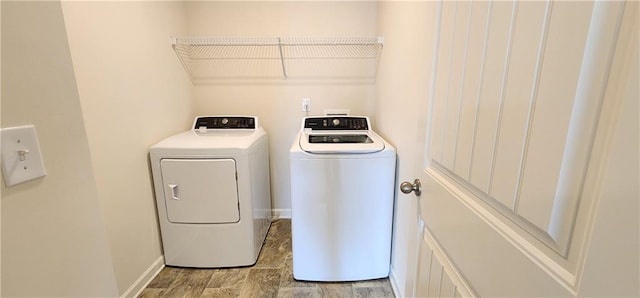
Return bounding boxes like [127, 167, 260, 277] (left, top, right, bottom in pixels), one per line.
[375, 1, 436, 296]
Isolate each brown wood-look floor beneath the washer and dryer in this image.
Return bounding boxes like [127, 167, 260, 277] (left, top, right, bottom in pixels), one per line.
[140, 219, 394, 298]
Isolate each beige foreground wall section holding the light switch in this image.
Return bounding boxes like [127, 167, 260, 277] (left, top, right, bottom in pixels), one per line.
[1, 1, 118, 297]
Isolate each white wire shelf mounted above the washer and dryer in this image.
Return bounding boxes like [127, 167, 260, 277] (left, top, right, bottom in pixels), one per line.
[172, 37, 383, 84]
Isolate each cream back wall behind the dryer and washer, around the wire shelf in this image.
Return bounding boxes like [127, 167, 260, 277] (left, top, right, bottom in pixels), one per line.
[187, 1, 385, 217]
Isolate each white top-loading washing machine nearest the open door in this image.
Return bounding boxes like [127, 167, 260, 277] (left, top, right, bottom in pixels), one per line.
[290, 116, 396, 281]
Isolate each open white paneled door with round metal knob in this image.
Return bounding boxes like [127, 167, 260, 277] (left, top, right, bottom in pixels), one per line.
[408, 1, 638, 297]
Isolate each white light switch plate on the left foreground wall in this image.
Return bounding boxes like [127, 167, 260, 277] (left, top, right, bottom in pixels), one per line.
[0, 125, 46, 186]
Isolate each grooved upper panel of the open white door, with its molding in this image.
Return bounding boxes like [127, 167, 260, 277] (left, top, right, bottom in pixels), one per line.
[428, 1, 624, 258]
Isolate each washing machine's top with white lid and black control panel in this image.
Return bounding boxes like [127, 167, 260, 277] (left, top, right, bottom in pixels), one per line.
[299, 116, 385, 154]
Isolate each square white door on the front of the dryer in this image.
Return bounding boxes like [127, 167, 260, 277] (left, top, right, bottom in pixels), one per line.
[160, 159, 240, 223]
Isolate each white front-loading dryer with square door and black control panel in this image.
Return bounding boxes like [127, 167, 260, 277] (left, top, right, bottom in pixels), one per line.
[150, 116, 271, 268]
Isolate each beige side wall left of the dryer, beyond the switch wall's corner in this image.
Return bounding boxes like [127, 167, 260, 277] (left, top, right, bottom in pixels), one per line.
[63, 1, 193, 294]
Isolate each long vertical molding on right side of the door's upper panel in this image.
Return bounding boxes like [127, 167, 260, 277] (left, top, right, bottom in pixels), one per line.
[548, 3, 624, 255]
